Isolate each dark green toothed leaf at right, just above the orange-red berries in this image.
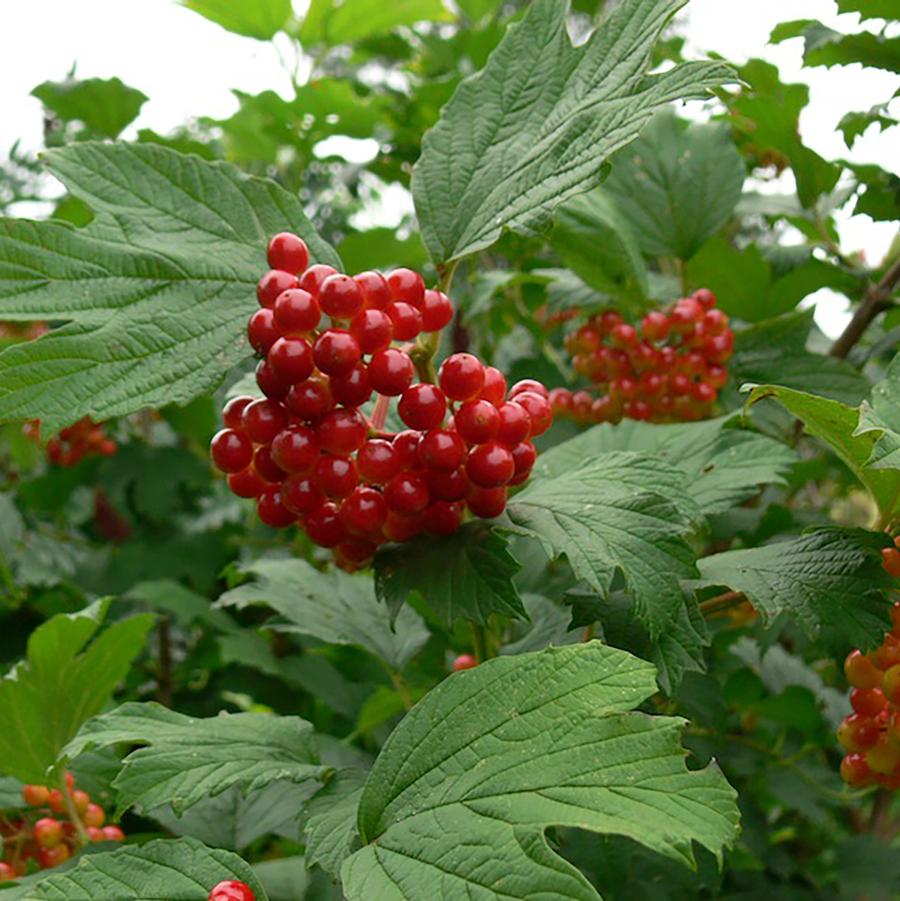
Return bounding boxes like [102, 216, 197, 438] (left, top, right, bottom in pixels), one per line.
[697, 528, 892, 647]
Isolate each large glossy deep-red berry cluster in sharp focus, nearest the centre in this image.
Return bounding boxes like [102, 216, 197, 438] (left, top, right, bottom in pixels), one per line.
[211, 234, 553, 569]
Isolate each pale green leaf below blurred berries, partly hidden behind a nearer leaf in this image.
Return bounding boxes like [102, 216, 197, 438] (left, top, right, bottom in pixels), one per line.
[536, 418, 797, 515]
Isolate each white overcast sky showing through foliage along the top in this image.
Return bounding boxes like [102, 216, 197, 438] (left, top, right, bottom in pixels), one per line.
[0, 0, 900, 333]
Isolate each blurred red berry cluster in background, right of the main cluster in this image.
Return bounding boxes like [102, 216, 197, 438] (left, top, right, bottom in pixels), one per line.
[550, 288, 734, 424]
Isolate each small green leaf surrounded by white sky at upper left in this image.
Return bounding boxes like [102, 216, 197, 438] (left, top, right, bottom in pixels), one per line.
[31, 78, 149, 138]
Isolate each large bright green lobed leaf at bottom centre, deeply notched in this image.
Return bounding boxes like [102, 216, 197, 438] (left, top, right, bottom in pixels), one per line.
[341, 642, 738, 901]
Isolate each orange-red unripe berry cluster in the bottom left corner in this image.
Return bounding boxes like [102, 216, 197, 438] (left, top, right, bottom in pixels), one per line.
[0, 773, 125, 882]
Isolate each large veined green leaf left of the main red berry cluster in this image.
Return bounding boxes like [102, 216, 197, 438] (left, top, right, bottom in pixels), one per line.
[0, 143, 340, 432]
